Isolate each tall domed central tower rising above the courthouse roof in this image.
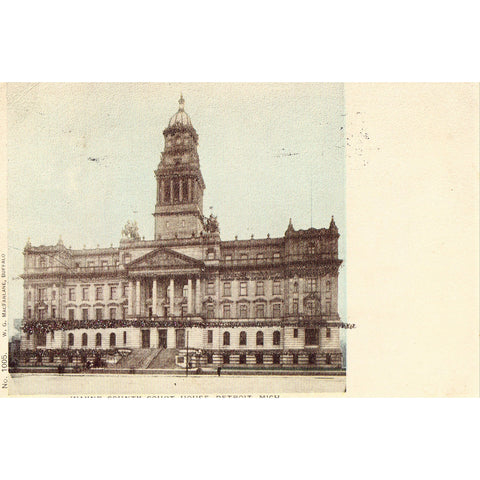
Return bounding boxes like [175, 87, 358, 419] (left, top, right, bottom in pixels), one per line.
[153, 96, 205, 240]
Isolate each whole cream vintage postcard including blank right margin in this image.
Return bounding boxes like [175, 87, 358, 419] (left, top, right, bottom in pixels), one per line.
[1, 83, 478, 397]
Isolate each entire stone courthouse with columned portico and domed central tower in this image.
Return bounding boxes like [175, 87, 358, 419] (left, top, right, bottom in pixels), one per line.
[20, 97, 342, 371]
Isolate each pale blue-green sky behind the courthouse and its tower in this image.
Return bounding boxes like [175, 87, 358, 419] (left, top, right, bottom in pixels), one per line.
[7, 83, 346, 330]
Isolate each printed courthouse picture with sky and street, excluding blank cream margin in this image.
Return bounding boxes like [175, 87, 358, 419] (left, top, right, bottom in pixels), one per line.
[7, 83, 353, 396]
